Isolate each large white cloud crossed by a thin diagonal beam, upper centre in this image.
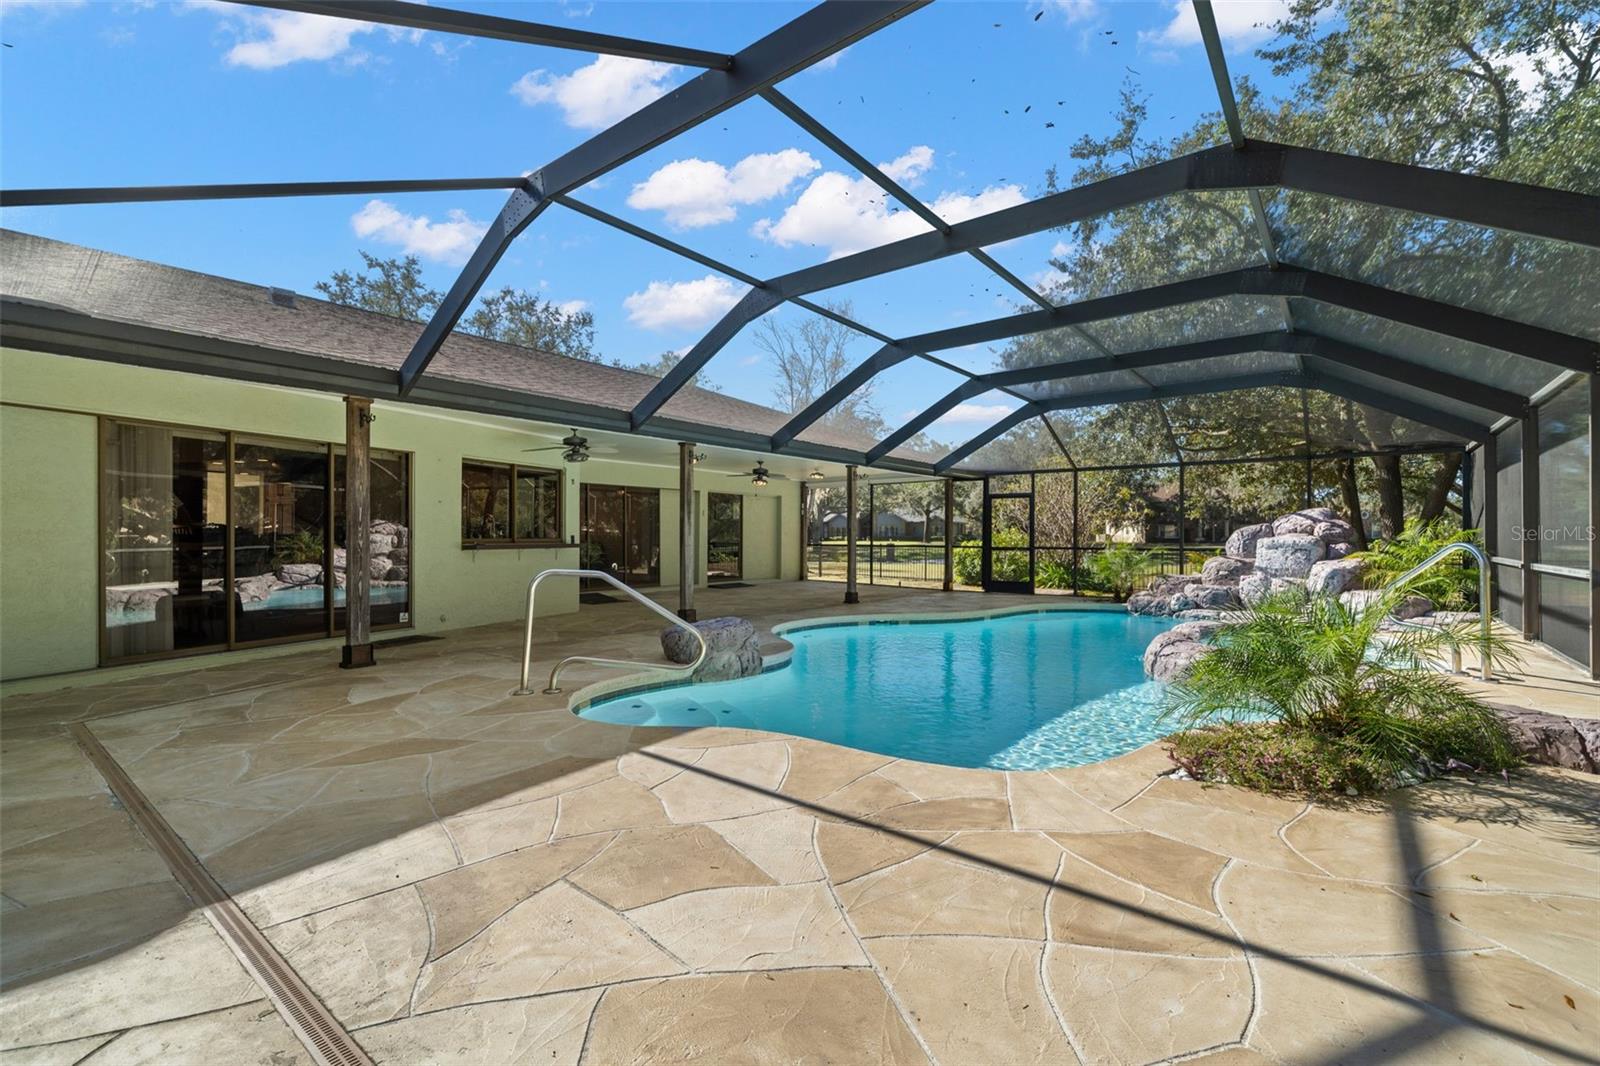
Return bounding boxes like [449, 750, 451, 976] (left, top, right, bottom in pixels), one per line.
[750, 146, 1027, 259]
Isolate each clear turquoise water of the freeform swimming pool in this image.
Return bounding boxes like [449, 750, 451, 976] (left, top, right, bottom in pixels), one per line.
[579, 610, 1173, 770]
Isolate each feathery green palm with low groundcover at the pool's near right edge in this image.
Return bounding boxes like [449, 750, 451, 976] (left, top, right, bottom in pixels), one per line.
[1163, 589, 1517, 791]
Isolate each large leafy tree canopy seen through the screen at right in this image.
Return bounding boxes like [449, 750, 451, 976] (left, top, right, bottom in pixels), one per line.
[973, 0, 1600, 535]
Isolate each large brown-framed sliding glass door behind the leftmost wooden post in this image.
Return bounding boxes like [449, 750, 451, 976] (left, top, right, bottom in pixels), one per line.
[101, 419, 411, 663]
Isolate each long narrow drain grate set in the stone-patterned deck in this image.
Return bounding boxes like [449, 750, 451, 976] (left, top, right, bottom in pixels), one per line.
[70, 722, 373, 1066]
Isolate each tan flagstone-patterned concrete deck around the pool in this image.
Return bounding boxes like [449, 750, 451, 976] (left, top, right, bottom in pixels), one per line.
[0, 583, 1600, 1066]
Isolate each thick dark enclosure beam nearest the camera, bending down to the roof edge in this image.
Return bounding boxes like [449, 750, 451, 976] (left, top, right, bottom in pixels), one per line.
[400, 0, 926, 393]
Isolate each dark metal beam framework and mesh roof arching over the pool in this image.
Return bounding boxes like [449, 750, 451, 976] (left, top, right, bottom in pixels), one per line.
[0, 0, 1600, 475]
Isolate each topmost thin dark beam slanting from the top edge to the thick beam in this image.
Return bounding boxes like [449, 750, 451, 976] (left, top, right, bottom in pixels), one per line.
[229, 0, 733, 70]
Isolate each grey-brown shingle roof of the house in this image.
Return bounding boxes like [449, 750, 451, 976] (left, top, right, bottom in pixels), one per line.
[0, 229, 874, 451]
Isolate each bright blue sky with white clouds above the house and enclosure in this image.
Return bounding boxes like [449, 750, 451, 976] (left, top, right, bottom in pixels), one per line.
[0, 0, 1282, 440]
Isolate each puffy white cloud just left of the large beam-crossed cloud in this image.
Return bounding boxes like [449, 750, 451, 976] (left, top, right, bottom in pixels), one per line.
[627, 149, 822, 229]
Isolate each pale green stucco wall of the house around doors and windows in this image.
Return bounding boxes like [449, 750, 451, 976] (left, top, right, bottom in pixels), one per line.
[0, 349, 798, 680]
